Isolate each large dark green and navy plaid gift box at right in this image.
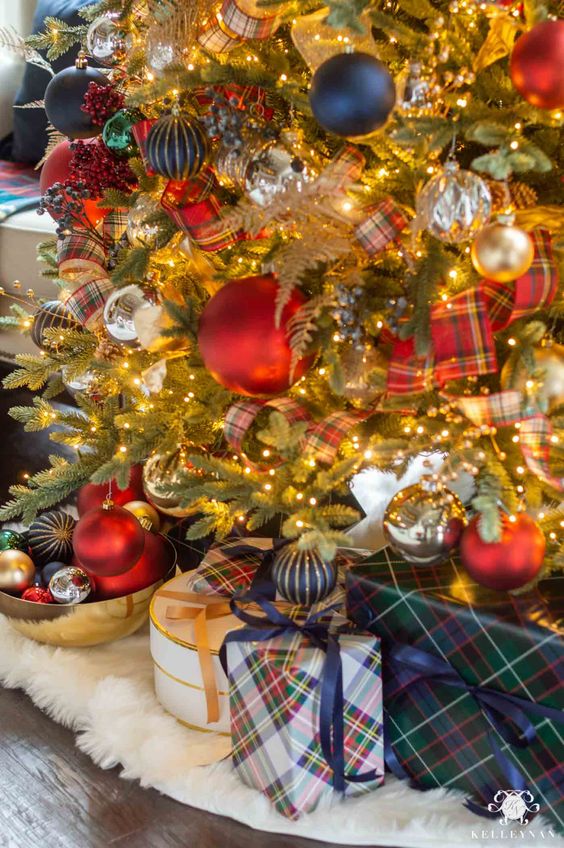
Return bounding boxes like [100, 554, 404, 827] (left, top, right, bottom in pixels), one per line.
[347, 548, 564, 827]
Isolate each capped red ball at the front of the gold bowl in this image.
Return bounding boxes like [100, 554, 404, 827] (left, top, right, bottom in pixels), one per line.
[72, 504, 145, 577]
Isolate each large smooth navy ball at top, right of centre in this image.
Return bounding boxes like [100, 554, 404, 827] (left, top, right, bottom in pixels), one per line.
[309, 53, 396, 138]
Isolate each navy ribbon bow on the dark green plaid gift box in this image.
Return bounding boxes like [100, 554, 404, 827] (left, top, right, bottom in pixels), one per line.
[384, 644, 564, 816]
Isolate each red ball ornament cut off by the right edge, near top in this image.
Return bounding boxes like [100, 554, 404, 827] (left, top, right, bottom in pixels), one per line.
[510, 21, 564, 109]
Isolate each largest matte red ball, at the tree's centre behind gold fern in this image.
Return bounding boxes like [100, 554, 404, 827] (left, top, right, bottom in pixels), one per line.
[198, 274, 313, 396]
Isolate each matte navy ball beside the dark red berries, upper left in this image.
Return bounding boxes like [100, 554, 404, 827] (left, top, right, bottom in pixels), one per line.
[45, 59, 109, 138]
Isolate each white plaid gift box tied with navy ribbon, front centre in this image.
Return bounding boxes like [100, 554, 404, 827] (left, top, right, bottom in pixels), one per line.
[225, 612, 384, 819]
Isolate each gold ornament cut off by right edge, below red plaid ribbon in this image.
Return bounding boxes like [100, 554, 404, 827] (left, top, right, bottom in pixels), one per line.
[501, 344, 564, 415]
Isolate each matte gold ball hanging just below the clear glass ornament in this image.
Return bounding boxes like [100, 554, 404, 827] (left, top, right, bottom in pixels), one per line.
[472, 221, 535, 283]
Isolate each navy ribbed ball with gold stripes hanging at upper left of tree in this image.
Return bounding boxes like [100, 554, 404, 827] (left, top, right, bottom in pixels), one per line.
[147, 113, 208, 180]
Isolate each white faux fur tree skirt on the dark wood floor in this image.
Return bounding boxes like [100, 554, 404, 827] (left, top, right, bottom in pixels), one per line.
[0, 617, 564, 848]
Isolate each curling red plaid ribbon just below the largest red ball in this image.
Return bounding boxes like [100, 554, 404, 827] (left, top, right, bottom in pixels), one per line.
[223, 398, 372, 463]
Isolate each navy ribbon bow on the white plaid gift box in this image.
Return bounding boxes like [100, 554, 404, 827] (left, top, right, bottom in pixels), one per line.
[220, 584, 381, 792]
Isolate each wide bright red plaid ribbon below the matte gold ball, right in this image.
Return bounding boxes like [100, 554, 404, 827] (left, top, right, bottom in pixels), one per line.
[388, 229, 558, 394]
